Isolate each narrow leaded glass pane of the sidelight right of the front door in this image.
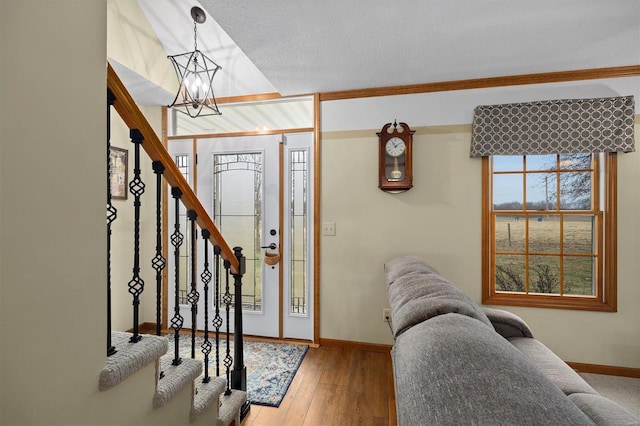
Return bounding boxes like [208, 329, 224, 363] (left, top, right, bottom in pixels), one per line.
[289, 150, 309, 314]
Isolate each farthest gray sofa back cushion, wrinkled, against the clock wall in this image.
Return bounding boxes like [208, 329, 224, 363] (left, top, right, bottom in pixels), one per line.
[385, 257, 494, 337]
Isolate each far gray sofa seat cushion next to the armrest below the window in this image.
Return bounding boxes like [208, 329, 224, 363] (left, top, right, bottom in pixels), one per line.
[509, 337, 597, 395]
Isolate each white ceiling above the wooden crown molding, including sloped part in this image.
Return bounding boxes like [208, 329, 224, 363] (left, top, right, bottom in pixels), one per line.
[138, 0, 640, 97]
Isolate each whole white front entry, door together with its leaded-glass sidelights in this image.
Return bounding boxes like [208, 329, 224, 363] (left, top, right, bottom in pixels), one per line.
[169, 132, 314, 340]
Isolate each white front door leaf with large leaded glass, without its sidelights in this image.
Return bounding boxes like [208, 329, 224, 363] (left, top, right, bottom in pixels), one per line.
[197, 135, 281, 337]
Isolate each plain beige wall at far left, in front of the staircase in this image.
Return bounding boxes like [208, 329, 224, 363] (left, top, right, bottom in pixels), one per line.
[0, 0, 106, 424]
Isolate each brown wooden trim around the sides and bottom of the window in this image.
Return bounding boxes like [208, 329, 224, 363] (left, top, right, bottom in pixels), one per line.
[481, 153, 618, 312]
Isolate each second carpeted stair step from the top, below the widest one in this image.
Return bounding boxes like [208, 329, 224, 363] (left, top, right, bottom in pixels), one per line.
[153, 355, 203, 408]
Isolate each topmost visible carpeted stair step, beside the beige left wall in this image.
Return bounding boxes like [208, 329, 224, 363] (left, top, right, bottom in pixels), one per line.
[98, 331, 169, 390]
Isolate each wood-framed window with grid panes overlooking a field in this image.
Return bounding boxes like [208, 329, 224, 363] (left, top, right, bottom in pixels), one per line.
[482, 153, 617, 311]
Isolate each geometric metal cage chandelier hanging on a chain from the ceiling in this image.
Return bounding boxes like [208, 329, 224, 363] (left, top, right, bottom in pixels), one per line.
[168, 6, 222, 118]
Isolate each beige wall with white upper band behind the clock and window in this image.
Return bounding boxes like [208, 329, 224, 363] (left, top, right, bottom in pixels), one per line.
[320, 78, 640, 368]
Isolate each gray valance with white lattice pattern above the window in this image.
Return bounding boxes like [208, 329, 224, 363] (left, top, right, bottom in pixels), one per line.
[471, 96, 635, 157]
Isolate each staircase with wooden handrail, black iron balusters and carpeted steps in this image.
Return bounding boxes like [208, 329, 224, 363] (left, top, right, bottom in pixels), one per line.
[98, 65, 250, 426]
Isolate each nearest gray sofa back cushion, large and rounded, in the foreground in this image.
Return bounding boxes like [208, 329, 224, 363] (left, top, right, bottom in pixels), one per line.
[392, 313, 593, 426]
